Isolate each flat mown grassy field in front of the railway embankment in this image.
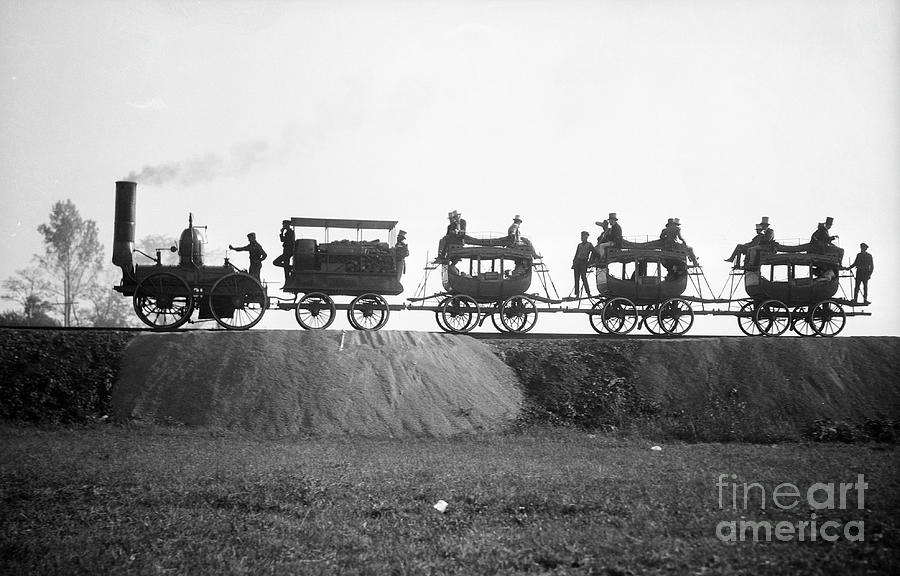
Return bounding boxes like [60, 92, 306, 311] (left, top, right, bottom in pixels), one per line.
[0, 425, 900, 575]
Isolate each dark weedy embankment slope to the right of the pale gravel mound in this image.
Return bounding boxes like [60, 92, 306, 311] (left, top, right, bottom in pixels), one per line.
[491, 338, 900, 442]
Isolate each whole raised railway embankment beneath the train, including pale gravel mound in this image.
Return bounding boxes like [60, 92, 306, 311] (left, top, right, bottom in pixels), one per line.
[7, 329, 900, 442]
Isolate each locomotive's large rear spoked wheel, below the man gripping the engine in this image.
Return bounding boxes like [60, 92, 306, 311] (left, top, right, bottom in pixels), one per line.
[209, 272, 269, 330]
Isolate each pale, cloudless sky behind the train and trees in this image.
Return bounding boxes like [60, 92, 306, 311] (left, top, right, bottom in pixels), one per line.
[0, 0, 900, 336]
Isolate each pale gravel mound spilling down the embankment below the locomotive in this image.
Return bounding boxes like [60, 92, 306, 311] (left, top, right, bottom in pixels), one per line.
[112, 330, 522, 437]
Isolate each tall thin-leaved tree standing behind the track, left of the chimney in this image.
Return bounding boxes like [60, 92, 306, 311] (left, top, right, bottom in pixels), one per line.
[38, 200, 103, 326]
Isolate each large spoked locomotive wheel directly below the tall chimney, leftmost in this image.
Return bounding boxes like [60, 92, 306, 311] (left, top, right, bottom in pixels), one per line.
[133, 272, 194, 330]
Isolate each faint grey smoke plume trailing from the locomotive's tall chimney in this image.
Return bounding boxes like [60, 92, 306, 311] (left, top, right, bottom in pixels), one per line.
[126, 140, 272, 186]
